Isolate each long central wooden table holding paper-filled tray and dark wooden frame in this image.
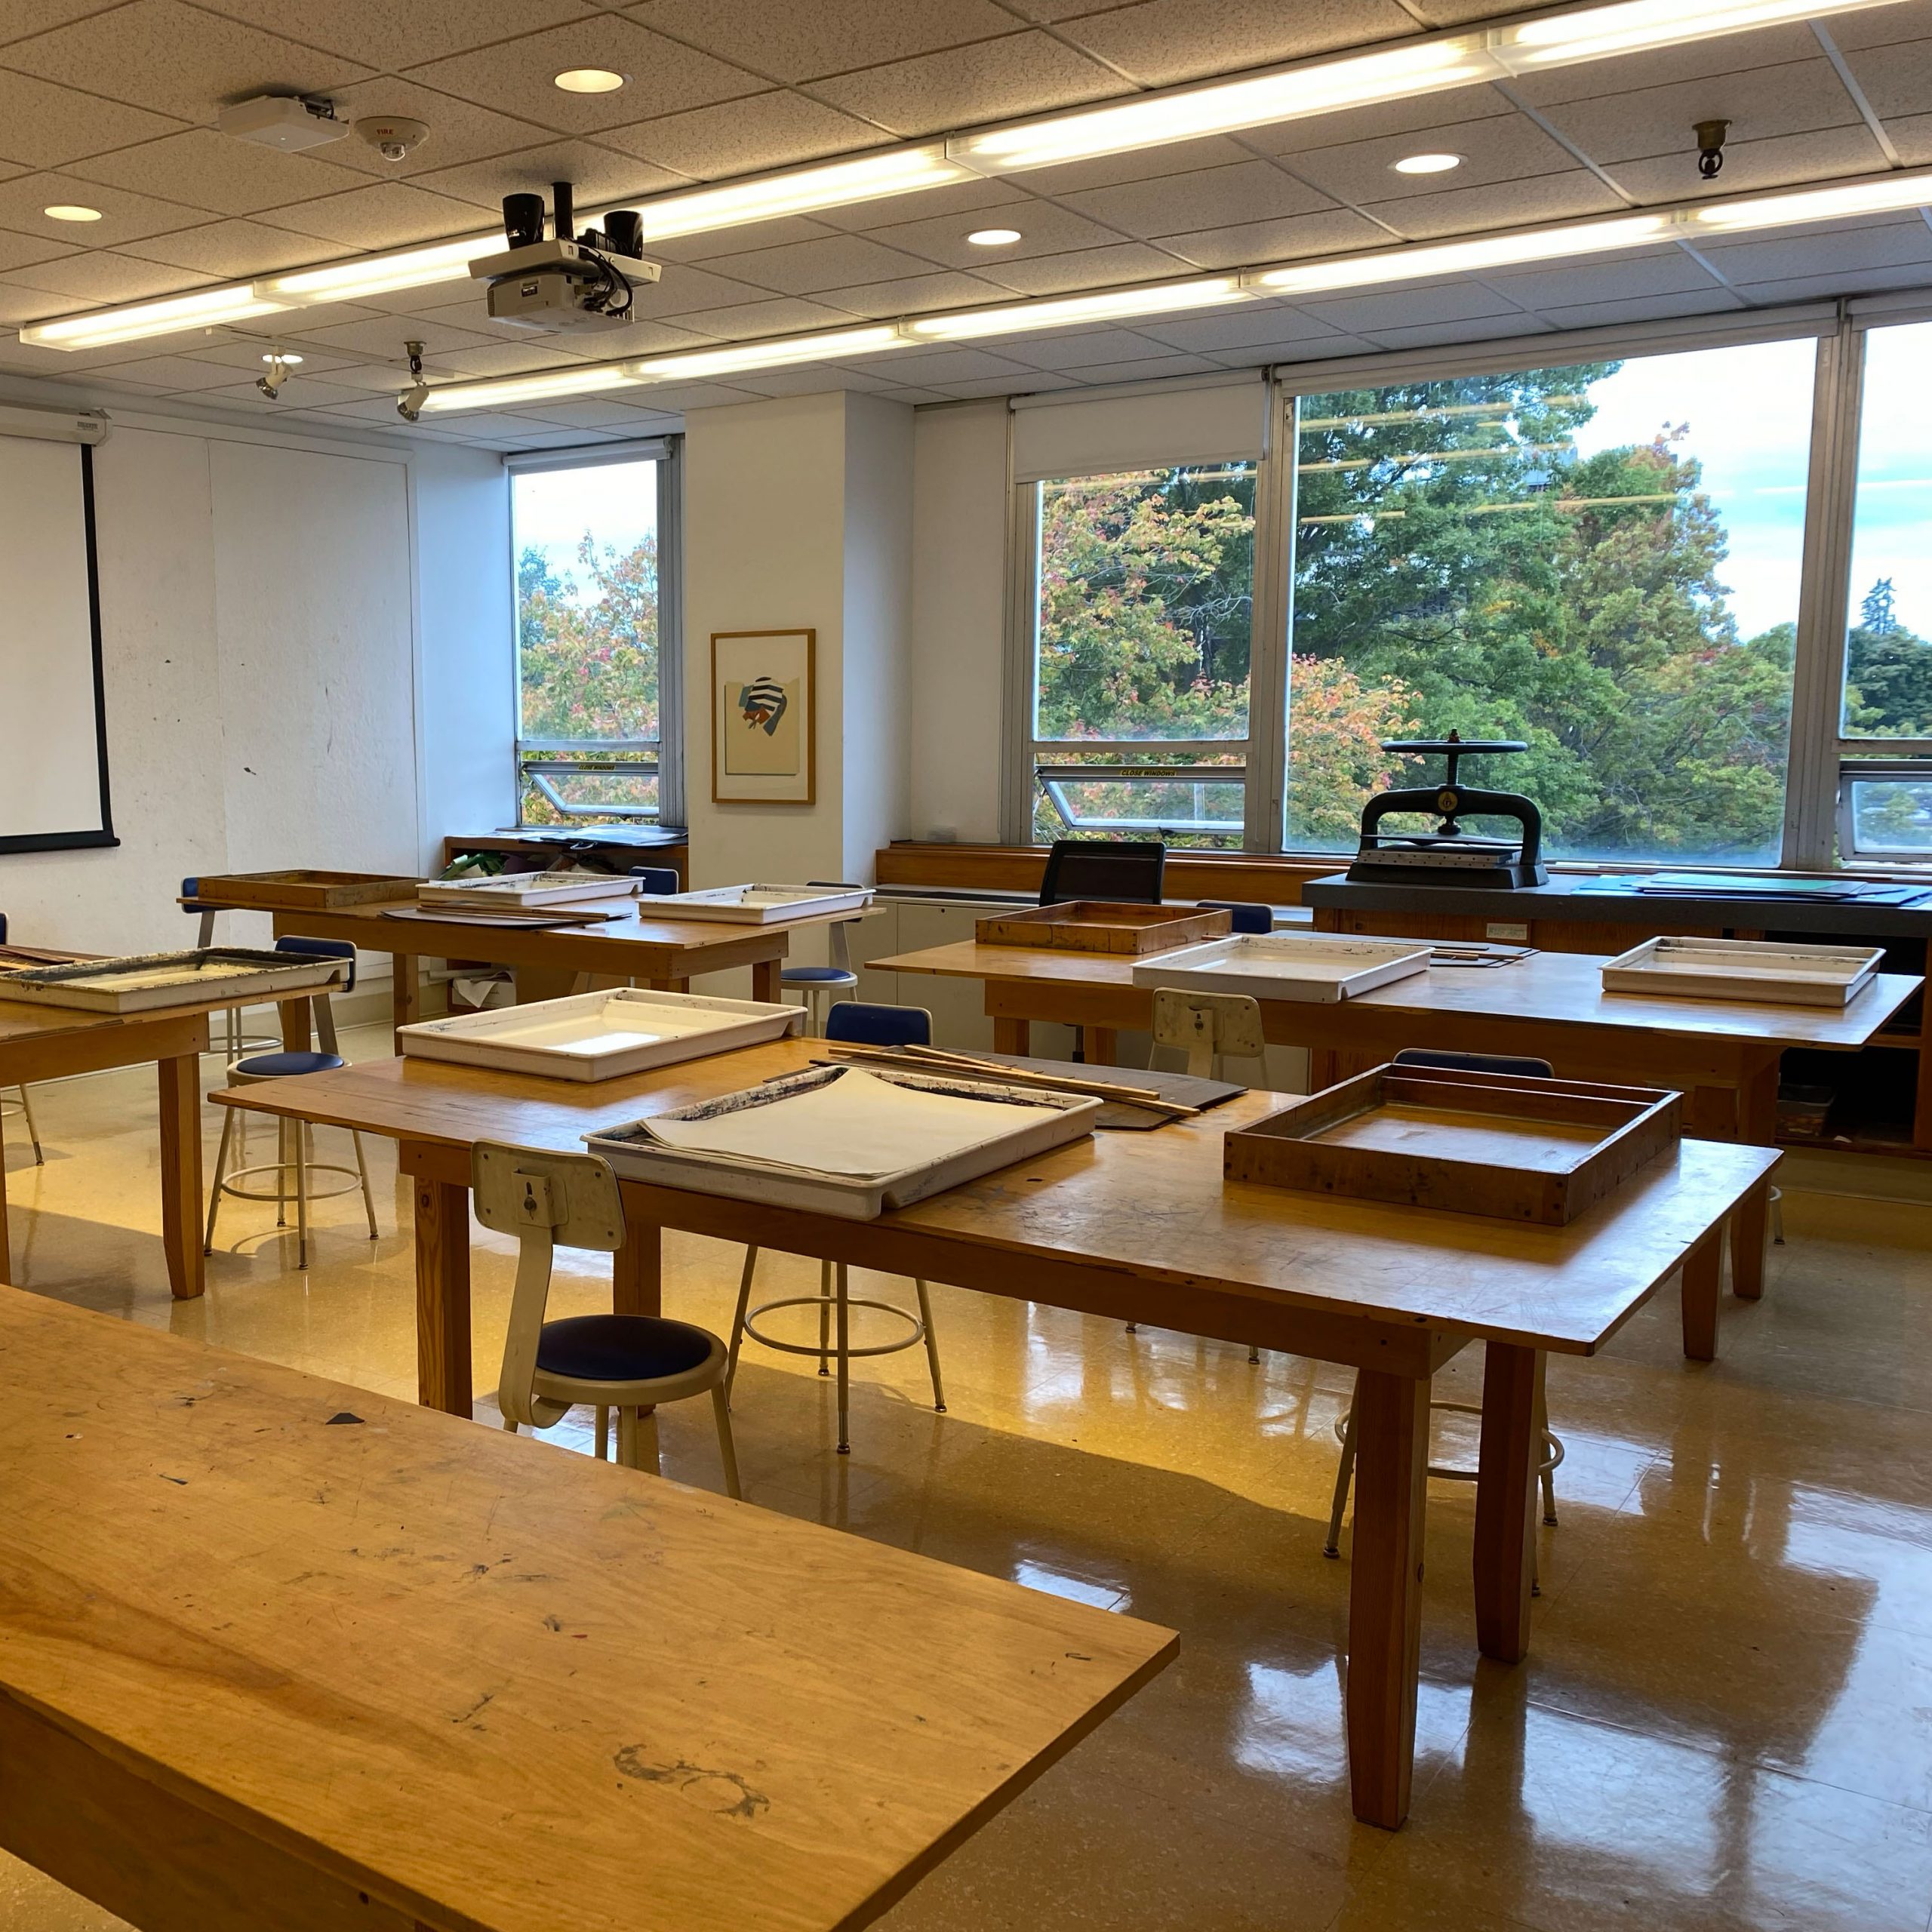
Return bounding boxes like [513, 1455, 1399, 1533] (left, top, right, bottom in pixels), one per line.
[214, 1041, 1777, 1826]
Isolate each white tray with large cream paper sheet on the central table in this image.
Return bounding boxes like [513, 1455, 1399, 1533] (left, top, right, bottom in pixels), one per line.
[583, 1066, 1101, 1213]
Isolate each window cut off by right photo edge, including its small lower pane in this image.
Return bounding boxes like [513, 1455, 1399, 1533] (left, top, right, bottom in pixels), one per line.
[1838, 323, 1932, 863]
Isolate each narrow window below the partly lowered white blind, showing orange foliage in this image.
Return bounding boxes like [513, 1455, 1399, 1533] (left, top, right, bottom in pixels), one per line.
[1029, 462, 1256, 848]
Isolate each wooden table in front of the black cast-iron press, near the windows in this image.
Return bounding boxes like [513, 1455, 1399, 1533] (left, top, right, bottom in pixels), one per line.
[872, 941, 1922, 1146]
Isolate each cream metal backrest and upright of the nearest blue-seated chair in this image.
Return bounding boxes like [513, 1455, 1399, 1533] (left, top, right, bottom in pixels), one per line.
[469, 1140, 624, 1429]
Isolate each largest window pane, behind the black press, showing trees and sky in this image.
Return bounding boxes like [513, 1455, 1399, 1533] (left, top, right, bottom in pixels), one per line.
[1289, 342, 1814, 863]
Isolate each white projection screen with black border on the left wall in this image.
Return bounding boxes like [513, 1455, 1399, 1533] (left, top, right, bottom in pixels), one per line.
[0, 437, 118, 852]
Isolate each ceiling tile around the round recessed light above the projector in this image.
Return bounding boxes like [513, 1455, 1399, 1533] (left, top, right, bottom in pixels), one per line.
[401, 14, 763, 134]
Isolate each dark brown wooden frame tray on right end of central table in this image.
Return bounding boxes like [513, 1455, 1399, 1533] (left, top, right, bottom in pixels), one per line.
[1221, 1065, 1683, 1227]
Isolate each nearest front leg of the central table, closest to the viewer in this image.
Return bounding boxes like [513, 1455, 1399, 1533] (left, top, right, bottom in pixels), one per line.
[1349, 1370, 1429, 1832]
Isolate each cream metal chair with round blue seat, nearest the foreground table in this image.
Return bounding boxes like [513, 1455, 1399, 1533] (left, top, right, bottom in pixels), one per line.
[469, 1140, 740, 1495]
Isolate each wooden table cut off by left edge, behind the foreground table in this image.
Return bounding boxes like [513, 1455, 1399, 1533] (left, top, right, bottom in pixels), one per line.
[0, 989, 326, 1298]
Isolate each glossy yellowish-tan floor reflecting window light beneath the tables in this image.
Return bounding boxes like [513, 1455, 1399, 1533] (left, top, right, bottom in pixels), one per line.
[0, 1034, 1932, 1932]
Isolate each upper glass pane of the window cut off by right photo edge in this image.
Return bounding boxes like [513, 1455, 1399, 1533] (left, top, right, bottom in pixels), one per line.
[1843, 323, 1932, 737]
